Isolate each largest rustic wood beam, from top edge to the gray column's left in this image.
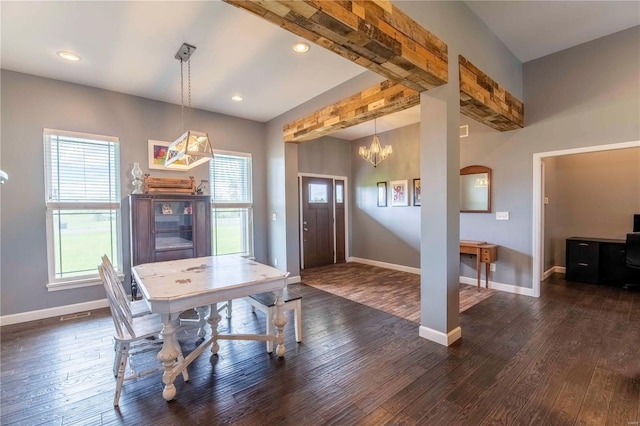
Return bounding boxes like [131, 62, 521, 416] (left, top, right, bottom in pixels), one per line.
[224, 0, 448, 92]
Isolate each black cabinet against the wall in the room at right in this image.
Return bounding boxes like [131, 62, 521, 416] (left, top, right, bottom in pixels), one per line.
[566, 237, 626, 285]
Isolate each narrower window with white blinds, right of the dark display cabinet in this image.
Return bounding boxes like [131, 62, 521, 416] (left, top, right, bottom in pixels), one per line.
[209, 151, 253, 256]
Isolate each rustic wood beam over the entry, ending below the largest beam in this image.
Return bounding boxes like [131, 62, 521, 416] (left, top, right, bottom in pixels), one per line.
[282, 80, 420, 143]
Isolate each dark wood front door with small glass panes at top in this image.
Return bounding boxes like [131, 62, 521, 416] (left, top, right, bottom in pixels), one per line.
[302, 177, 334, 268]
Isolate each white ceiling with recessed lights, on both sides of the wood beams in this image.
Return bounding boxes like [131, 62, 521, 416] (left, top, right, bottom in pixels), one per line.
[0, 1, 640, 140]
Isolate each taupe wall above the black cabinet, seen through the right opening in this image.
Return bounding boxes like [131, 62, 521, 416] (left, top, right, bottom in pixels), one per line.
[545, 148, 640, 266]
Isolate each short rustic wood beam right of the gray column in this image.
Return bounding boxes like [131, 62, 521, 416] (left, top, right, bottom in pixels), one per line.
[459, 56, 524, 132]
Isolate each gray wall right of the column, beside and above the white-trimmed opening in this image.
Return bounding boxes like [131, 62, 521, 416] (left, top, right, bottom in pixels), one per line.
[461, 27, 640, 287]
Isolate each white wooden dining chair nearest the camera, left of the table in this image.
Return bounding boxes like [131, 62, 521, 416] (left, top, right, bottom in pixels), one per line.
[98, 265, 189, 406]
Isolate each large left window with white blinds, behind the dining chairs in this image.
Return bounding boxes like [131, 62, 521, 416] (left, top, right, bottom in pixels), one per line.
[44, 129, 122, 290]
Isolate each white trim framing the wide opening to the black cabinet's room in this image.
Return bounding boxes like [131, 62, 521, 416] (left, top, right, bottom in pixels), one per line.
[531, 141, 640, 297]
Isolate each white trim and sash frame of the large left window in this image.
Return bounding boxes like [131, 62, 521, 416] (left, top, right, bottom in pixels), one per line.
[42, 128, 124, 292]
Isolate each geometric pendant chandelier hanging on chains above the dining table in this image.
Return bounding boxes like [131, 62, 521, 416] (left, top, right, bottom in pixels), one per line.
[164, 43, 213, 170]
